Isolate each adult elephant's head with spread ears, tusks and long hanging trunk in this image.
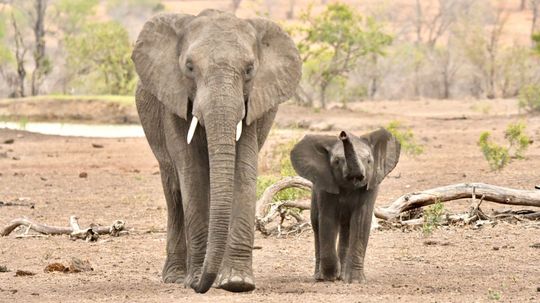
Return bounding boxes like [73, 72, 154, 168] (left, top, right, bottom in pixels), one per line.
[132, 10, 301, 292]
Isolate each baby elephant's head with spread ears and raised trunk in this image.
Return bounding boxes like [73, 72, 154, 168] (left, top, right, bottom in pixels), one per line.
[291, 128, 401, 194]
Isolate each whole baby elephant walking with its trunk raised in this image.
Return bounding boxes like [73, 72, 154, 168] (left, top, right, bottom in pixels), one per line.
[291, 128, 400, 283]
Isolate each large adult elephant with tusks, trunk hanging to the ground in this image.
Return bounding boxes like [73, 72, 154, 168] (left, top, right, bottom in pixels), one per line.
[132, 10, 301, 293]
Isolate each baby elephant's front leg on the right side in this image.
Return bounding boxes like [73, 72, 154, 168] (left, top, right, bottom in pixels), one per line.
[341, 190, 377, 283]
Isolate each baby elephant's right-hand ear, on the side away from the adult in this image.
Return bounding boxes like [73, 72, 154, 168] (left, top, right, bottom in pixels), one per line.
[361, 128, 401, 189]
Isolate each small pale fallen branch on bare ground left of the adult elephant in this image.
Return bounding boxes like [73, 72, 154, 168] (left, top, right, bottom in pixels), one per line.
[0, 216, 125, 241]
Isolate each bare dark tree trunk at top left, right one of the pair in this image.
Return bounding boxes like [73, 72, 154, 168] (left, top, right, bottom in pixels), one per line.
[32, 0, 47, 96]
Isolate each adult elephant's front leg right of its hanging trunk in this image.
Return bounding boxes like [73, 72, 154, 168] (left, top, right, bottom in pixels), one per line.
[217, 125, 258, 292]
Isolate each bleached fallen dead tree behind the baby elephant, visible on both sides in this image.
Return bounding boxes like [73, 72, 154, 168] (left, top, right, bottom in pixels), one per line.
[256, 177, 540, 235]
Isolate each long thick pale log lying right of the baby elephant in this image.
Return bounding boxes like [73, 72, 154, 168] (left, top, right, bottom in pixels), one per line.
[375, 183, 540, 220]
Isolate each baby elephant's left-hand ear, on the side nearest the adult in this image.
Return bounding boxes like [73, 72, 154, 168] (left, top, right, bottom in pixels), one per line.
[291, 135, 339, 194]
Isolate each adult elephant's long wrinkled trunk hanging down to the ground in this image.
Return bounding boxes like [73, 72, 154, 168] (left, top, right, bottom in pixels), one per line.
[192, 81, 243, 293]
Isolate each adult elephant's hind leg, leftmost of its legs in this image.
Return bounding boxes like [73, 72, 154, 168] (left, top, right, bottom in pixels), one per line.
[160, 165, 187, 283]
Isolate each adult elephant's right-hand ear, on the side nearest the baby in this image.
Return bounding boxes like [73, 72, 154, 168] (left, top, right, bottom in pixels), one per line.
[246, 18, 302, 125]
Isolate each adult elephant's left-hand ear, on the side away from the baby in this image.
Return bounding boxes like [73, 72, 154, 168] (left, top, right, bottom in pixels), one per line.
[131, 14, 194, 119]
